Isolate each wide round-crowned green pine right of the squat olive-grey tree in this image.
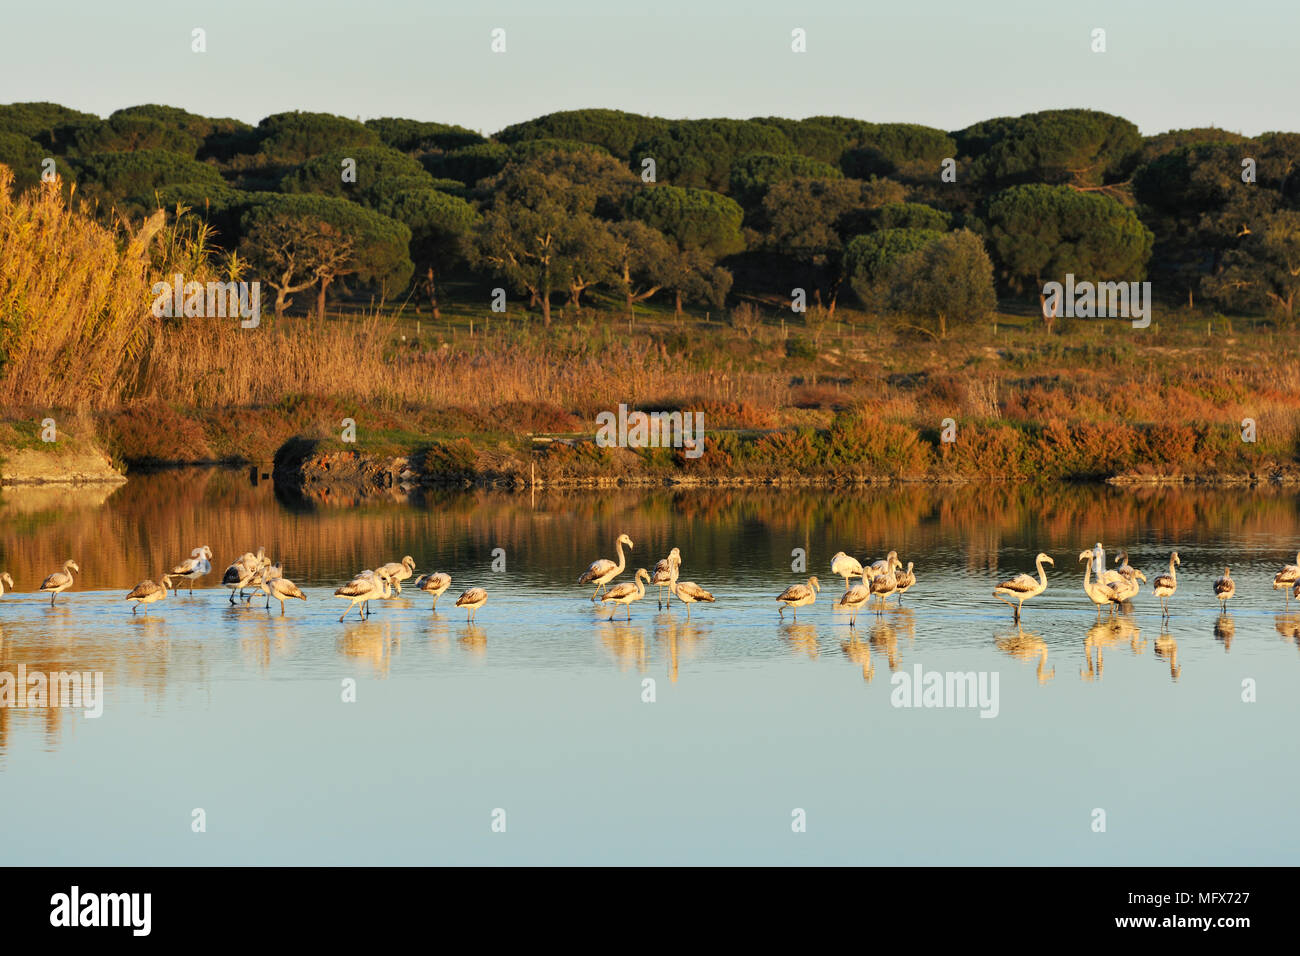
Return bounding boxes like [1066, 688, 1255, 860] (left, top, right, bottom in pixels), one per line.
[985, 183, 1153, 330]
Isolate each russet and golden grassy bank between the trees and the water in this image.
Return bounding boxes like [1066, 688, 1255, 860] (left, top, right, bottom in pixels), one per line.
[0, 282, 1300, 480]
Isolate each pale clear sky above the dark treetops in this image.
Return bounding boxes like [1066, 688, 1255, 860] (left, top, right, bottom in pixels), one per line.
[0, 0, 1300, 134]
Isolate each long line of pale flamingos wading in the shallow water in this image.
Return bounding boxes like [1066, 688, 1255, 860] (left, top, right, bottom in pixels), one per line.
[0, 535, 1300, 627]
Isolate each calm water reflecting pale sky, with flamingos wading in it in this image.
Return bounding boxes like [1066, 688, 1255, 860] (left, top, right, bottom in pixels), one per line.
[0, 471, 1300, 864]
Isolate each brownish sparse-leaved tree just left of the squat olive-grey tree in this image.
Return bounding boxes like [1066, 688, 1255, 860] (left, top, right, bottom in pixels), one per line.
[761, 179, 902, 316]
